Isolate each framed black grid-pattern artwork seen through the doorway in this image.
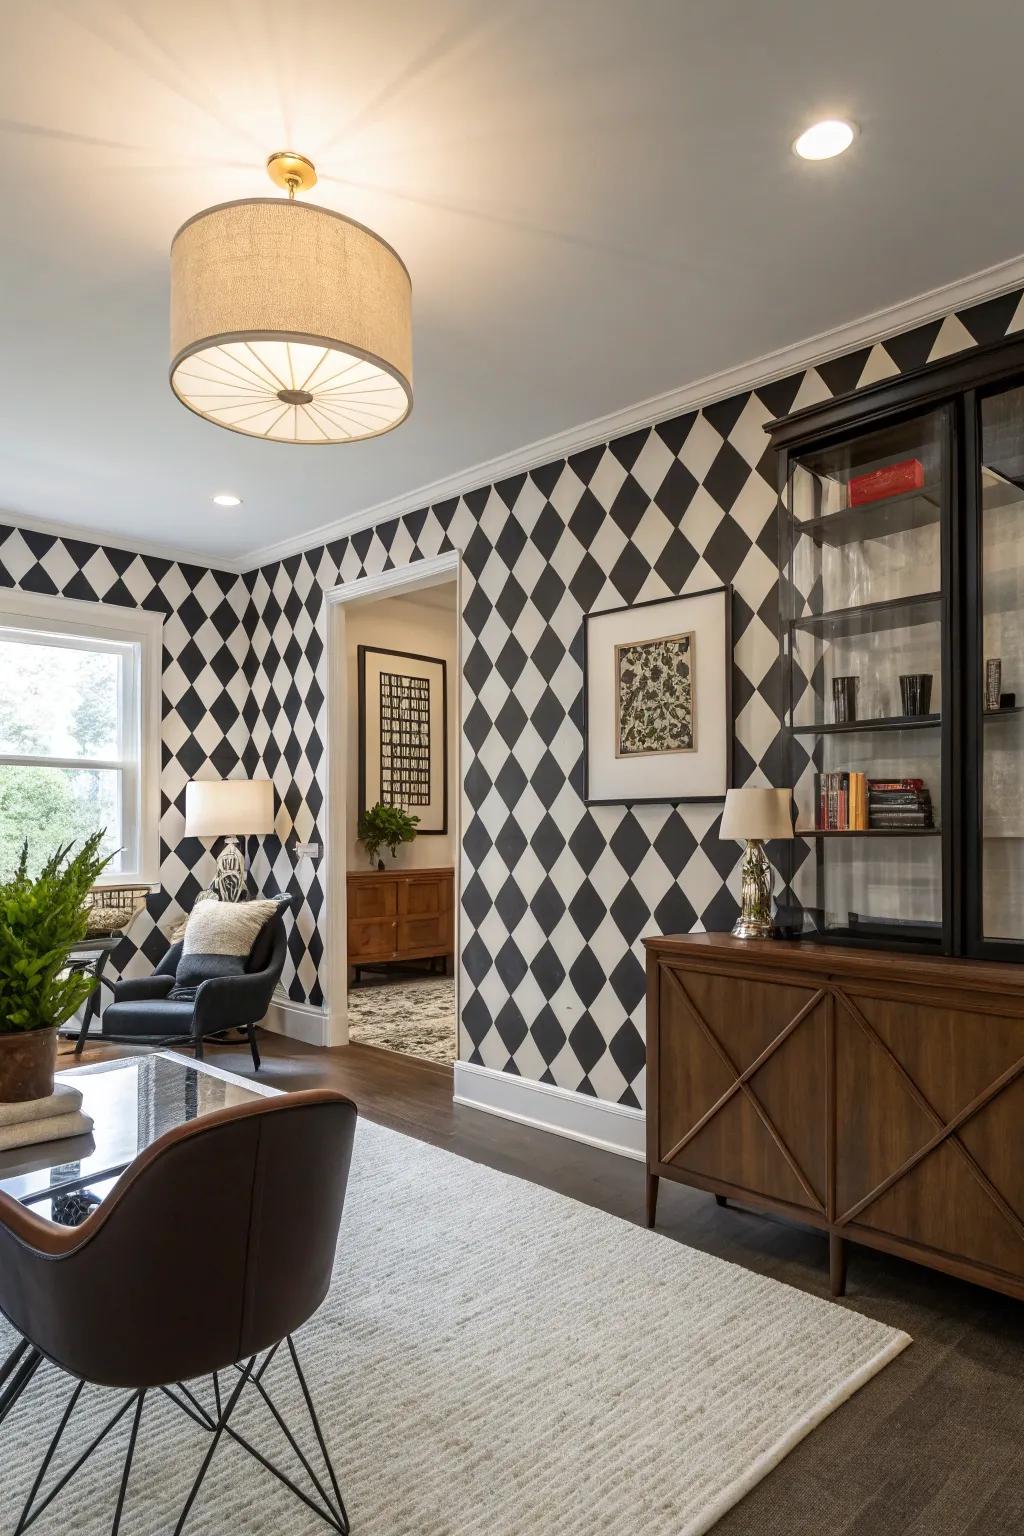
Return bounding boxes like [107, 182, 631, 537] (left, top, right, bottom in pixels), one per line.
[358, 645, 448, 837]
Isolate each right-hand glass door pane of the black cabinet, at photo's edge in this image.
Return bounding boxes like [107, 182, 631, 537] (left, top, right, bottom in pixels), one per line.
[969, 387, 1024, 943]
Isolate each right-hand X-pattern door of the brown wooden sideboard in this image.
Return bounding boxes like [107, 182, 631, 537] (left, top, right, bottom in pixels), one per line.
[835, 986, 1024, 1279]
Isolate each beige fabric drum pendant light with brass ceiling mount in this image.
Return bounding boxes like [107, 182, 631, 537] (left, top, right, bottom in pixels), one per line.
[170, 151, 413, 444]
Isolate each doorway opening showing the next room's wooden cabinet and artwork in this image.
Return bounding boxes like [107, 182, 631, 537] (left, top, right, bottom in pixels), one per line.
[329, 558, 461, 1066]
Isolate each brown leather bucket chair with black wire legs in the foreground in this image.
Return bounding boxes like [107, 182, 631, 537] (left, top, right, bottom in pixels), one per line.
[0, 1091, 356, 1536]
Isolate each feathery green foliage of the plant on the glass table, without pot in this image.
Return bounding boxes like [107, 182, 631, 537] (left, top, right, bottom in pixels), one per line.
[0, 831, 112, 1034]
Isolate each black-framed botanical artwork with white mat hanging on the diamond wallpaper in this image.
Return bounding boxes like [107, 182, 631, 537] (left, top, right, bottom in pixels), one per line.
[583, 587, 732, 805]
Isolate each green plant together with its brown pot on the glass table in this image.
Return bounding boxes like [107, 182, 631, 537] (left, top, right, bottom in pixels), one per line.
[0, 831, 109, 1104]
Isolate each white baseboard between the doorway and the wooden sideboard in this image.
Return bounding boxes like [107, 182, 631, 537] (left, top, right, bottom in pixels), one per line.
[454, 1061, 646, 1161]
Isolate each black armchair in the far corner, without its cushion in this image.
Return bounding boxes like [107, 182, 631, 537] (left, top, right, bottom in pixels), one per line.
[103, 914, 287, 1071]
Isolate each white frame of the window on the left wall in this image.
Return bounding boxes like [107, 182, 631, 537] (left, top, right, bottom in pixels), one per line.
[0, 590, 164, 885]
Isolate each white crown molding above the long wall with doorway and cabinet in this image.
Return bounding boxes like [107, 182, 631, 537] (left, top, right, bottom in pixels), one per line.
[236, 255, 1024, 568]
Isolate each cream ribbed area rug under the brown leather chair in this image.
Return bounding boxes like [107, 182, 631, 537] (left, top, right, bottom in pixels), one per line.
[0, 1121, 910, 1536]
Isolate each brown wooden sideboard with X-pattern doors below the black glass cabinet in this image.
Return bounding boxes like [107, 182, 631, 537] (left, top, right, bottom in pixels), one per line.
[646, 934, 1024, 1299]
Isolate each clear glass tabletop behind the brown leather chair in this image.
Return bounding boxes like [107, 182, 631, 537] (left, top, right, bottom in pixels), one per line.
[0, 1051, 278, 1215]
